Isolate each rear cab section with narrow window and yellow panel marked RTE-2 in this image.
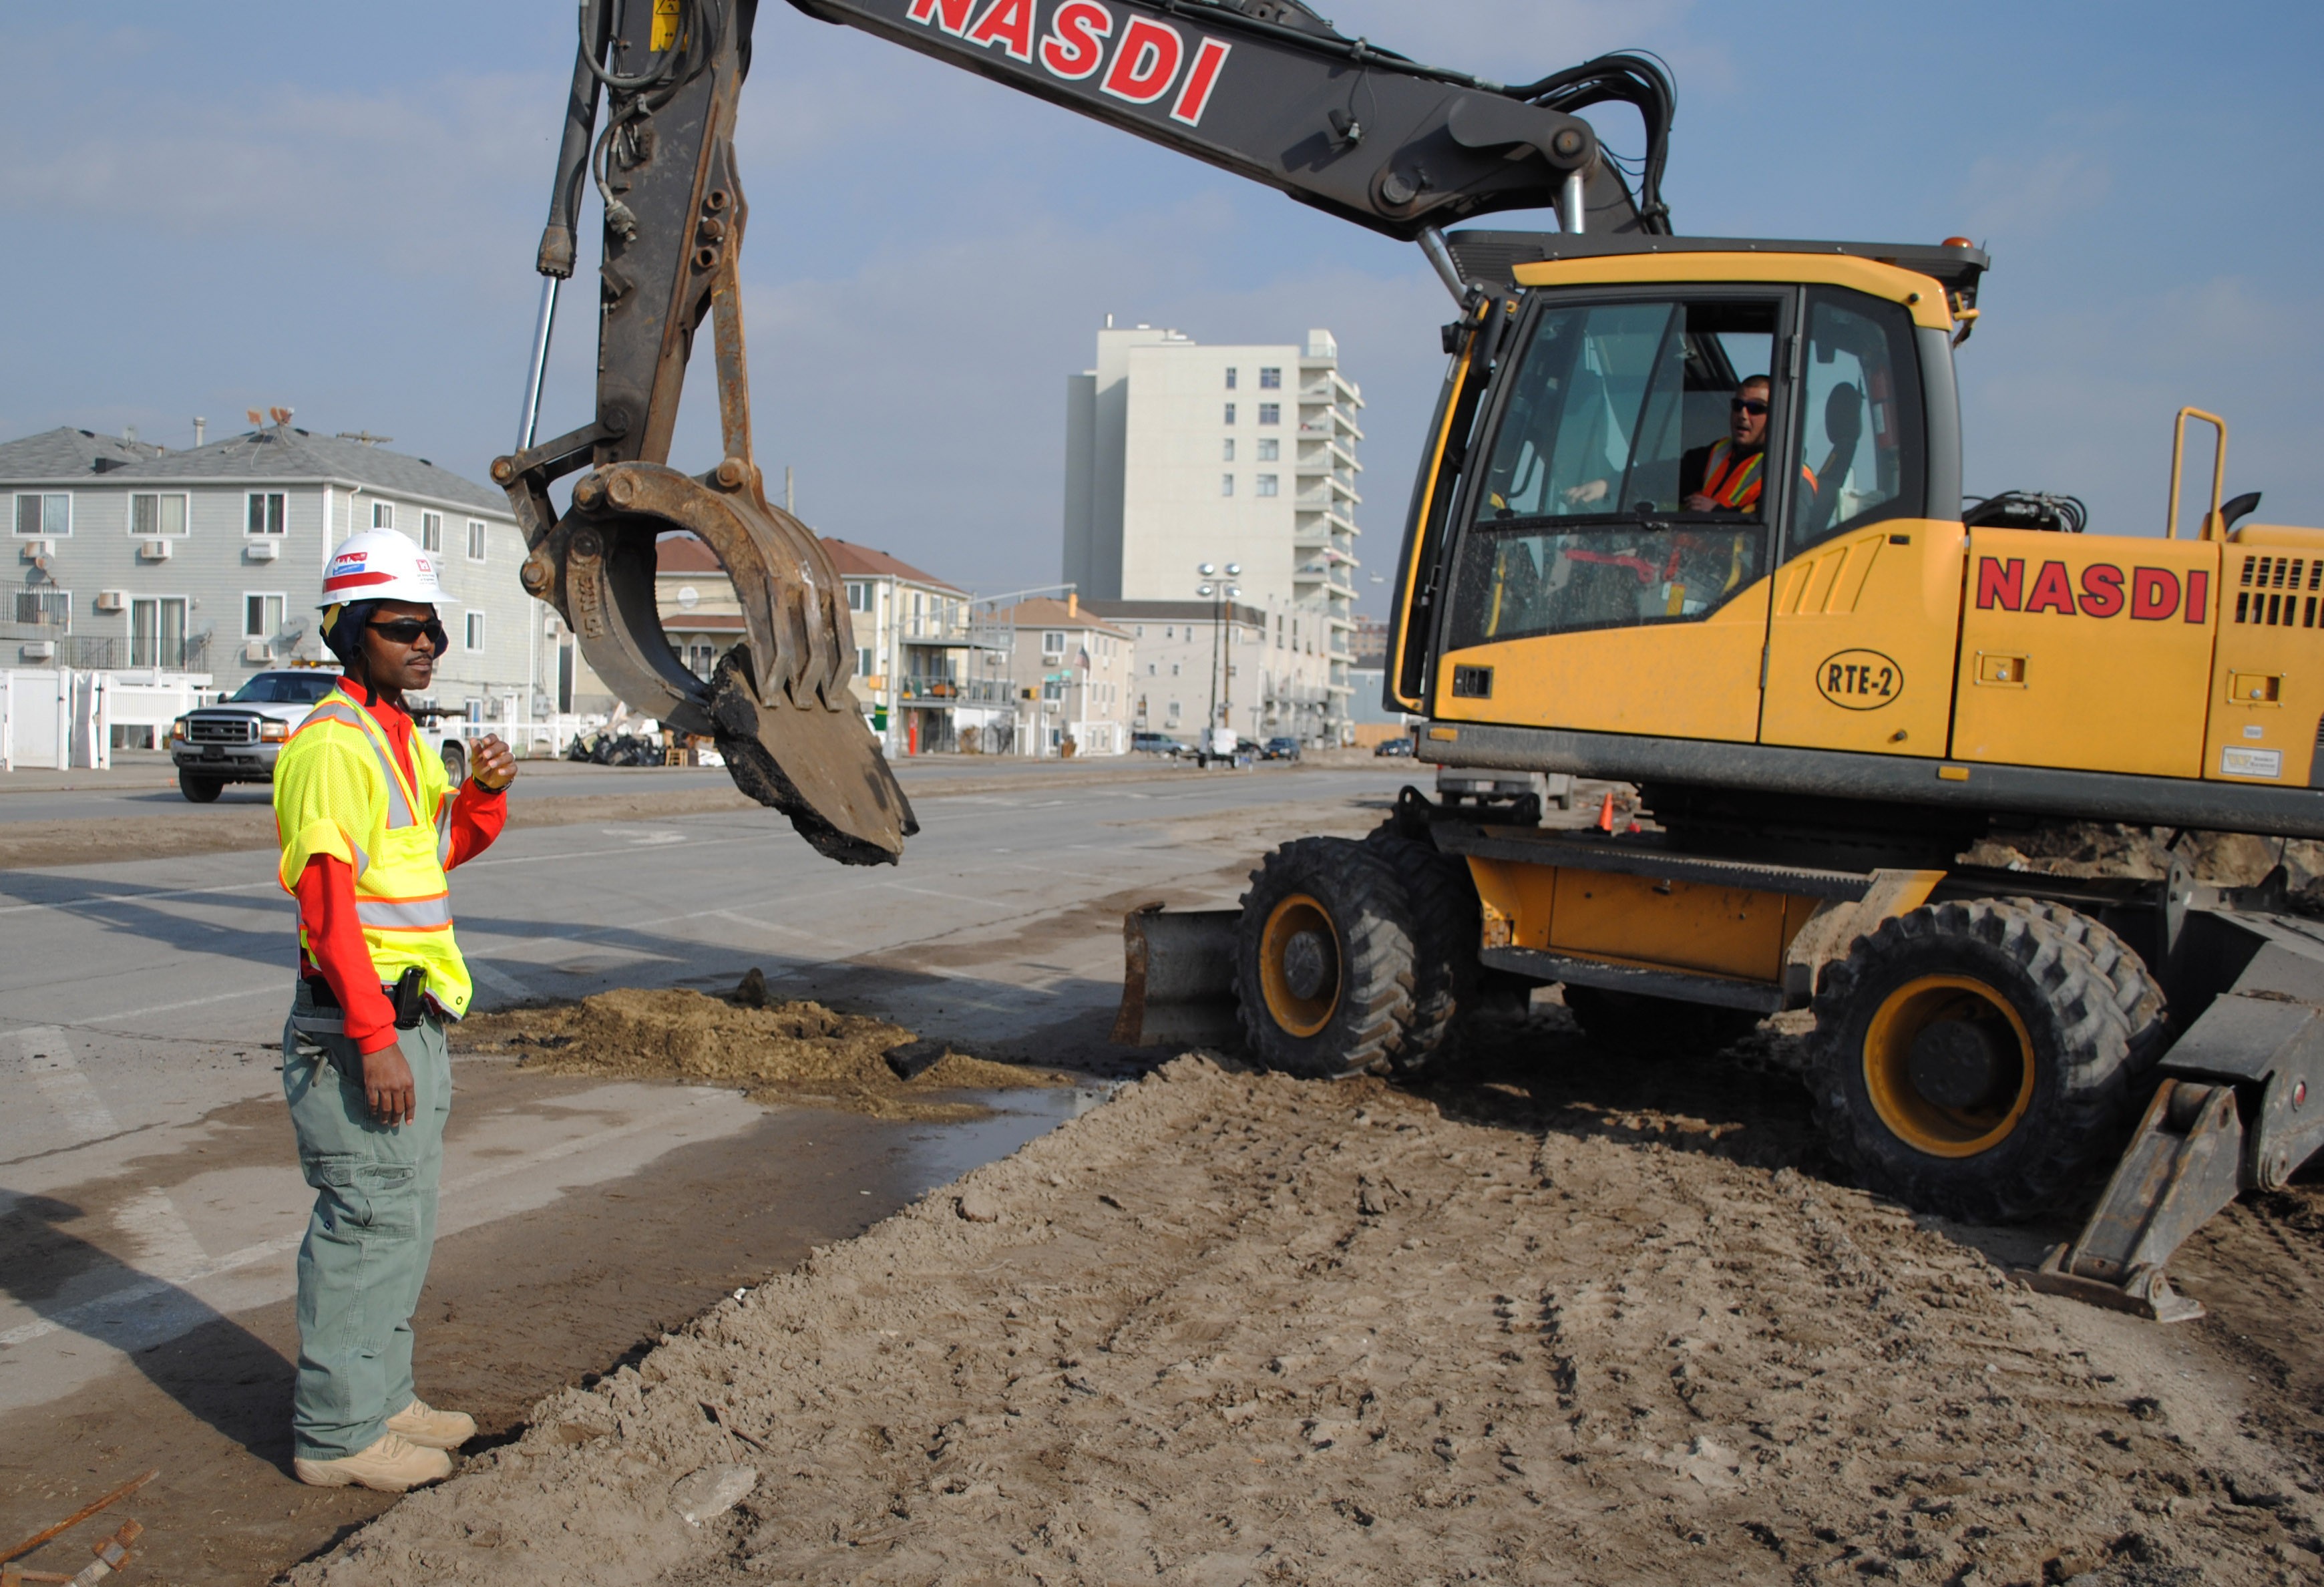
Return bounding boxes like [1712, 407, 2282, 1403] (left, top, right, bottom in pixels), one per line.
[1759, 286, 1966, 755]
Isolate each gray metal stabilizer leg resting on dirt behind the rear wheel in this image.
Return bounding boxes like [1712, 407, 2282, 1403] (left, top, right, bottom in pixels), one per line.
[2024, 908, 2324, 1322]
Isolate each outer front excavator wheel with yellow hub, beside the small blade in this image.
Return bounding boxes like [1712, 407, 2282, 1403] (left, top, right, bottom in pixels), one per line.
[1234, 836, 1413, 1081]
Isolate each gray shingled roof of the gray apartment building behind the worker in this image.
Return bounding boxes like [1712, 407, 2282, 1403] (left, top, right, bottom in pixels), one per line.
[0, 425, 509, 518]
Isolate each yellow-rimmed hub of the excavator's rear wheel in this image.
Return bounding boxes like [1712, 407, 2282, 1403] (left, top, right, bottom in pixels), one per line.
[1864, 976, 2036, 1157]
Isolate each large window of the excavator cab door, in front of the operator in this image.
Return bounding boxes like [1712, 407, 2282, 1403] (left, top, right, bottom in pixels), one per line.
[1452, 297, 1782, 646]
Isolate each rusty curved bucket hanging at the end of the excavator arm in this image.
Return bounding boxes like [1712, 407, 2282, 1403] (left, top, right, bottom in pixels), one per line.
[534, 458, 920, 864]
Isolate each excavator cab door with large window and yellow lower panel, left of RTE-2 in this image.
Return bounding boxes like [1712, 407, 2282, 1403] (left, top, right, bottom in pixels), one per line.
[1429, 288, 1796, 743]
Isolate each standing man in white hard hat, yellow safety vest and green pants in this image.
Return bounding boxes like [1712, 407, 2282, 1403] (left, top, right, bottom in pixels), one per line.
[274, 530, 516, 1491]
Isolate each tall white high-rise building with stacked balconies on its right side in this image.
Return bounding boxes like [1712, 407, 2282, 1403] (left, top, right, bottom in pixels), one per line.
[1064, 325, 1364, 739]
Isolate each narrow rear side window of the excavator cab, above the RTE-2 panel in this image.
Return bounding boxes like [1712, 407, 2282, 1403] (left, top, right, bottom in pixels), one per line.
[1787, 286, 1927, 553]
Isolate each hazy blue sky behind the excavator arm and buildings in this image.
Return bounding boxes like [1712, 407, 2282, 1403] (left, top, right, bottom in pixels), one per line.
[0, 0, 2324, 608]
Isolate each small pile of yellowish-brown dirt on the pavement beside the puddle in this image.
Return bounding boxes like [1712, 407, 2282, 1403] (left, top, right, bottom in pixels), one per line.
[455, 971, 1064, 1120]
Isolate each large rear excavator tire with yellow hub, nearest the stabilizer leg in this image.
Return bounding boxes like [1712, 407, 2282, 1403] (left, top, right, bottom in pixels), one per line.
[1810, 899, 2131, 1222]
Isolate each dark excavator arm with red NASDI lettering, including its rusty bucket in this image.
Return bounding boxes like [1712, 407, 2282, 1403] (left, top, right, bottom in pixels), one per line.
[493, 0, 1671, 864]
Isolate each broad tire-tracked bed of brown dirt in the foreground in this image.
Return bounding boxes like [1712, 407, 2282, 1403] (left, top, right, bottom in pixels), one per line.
[290, 1059, 2324, 1587]
